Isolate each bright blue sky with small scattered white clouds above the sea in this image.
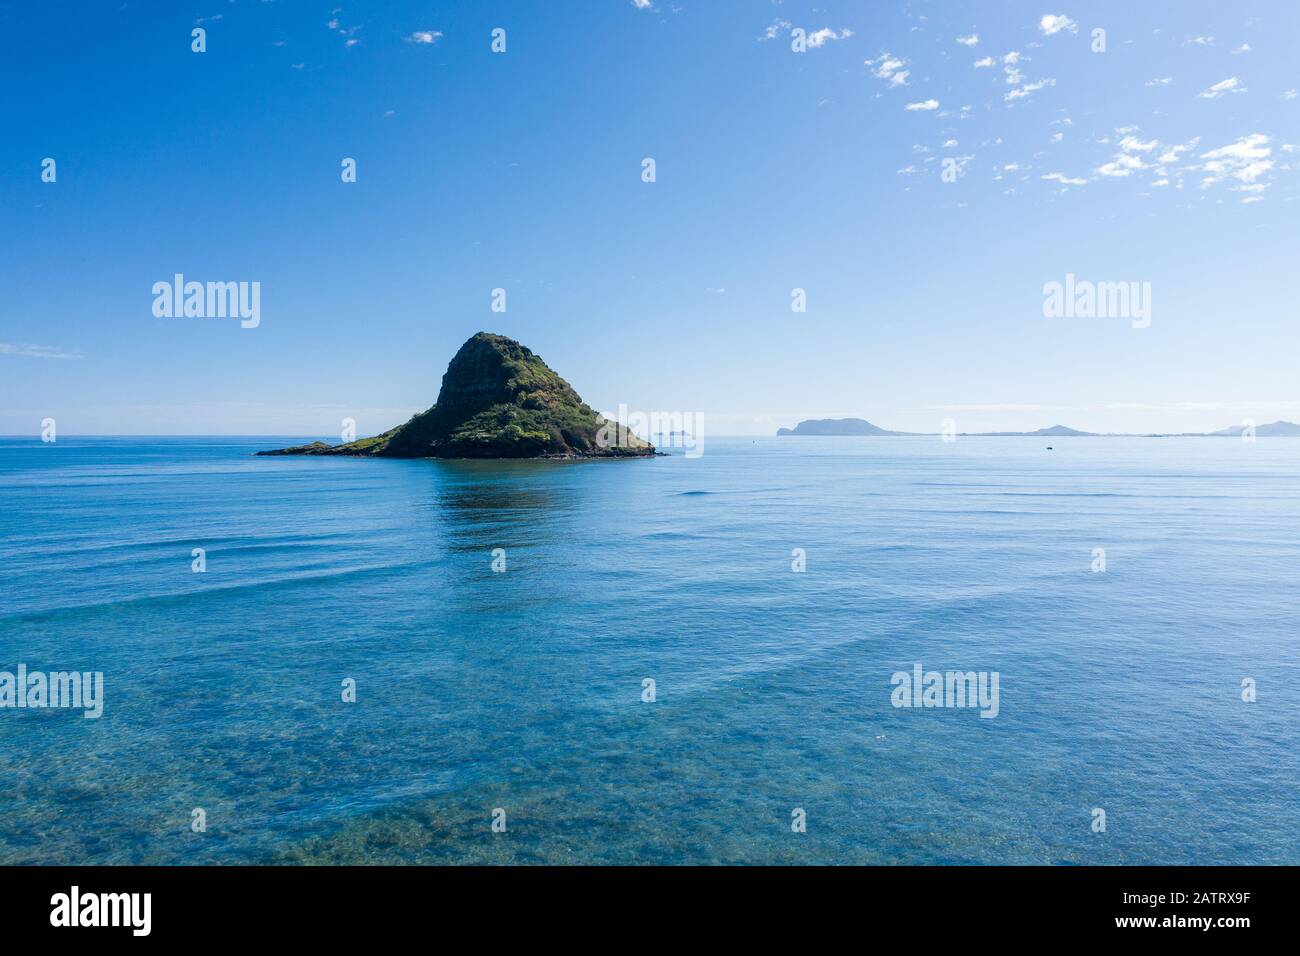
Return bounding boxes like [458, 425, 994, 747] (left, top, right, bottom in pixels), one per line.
[0, 0, 1300, 436]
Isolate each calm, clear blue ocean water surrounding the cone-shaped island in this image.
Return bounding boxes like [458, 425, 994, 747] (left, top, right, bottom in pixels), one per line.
[0, 438, 1300, 864]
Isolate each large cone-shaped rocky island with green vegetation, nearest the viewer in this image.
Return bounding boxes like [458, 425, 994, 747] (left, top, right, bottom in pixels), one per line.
[257, 332, 655, 458]
